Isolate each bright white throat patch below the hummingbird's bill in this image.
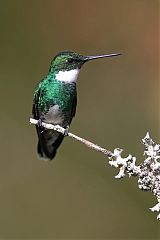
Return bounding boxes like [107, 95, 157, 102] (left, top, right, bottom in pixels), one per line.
[56, 68, 79, 83]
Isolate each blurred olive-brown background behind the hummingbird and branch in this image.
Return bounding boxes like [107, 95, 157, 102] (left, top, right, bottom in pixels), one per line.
[0, 0, 160, 239]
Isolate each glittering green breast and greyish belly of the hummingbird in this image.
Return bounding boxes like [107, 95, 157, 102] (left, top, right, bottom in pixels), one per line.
[38, 78, 76, 127]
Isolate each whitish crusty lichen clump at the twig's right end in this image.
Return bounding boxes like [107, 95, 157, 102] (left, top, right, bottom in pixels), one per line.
[109, 133, 160, 220]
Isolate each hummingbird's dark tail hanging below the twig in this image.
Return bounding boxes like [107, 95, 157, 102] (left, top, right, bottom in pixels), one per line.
[37, 130, 64, 160]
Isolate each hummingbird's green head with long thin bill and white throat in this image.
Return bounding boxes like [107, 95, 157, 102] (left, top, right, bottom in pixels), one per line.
[49, 51, 120, 82]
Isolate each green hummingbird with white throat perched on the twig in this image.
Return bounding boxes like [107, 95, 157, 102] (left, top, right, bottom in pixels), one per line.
[32, 51, 120, 160]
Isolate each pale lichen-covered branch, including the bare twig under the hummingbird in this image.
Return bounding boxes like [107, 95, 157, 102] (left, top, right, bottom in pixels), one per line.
[30, 118, 160, 220]
